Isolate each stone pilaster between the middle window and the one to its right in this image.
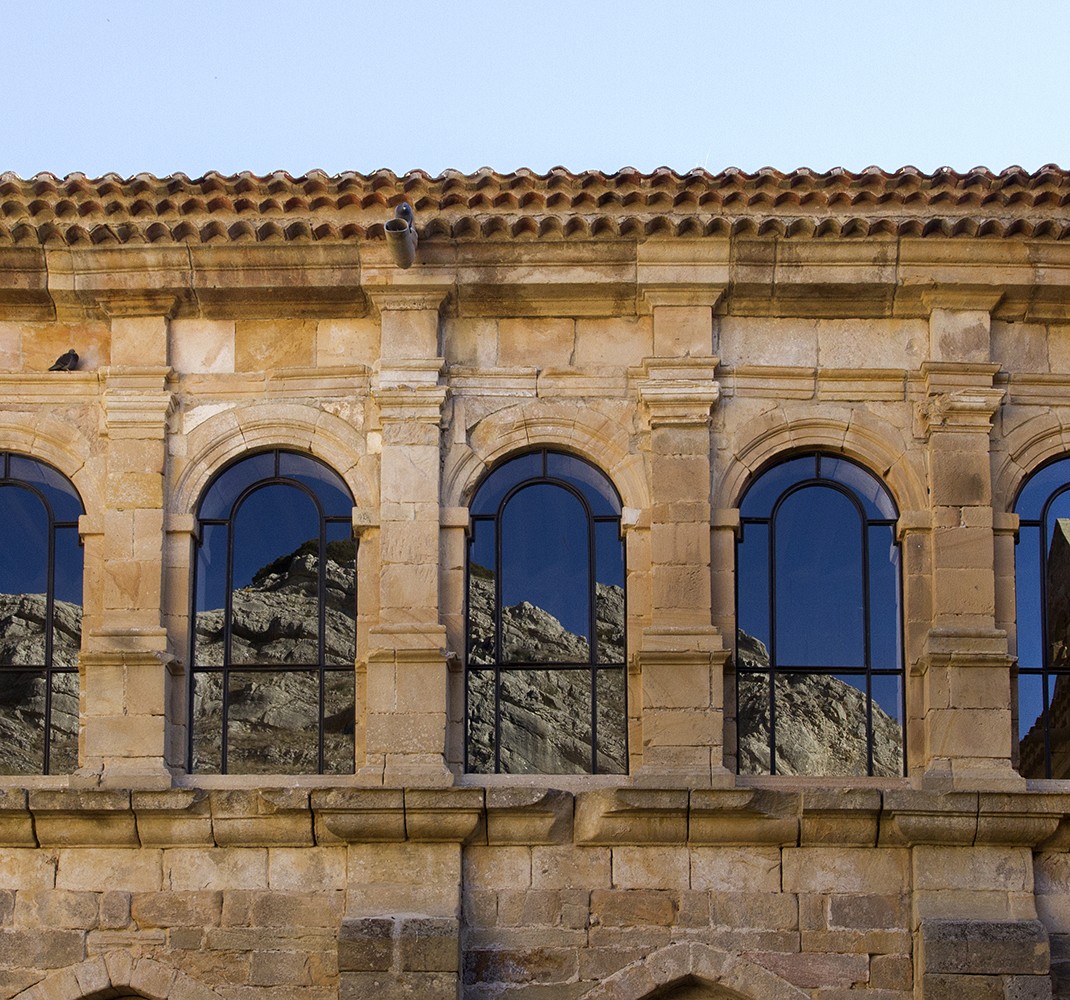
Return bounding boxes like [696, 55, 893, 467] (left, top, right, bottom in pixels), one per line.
[636, 352, 729, 786]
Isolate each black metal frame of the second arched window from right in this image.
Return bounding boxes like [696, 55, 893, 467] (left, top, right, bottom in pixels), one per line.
[734, 451, 906, 776]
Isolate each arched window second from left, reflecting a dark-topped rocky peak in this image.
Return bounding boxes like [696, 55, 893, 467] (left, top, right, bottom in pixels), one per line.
[189, 450, 356, 774]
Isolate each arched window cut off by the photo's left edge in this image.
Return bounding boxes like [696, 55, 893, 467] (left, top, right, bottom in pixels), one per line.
[0, 452, 83, 774]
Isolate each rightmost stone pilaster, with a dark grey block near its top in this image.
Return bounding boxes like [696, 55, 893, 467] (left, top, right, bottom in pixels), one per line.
[916, 303, 1021, 788]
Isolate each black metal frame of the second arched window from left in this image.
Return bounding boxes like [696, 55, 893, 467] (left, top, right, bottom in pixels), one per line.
[186, 448, 356, 774]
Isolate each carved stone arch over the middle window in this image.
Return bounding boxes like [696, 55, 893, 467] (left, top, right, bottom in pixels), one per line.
[442, 400, 649, 508]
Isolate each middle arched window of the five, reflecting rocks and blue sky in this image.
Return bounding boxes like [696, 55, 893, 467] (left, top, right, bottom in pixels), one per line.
[465, 450, 628, 774]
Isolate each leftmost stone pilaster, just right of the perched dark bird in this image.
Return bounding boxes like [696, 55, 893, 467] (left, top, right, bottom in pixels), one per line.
[78, 297, 179, 787]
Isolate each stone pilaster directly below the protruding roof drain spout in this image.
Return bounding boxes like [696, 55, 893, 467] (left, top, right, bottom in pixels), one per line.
[360, 289, 453, 785]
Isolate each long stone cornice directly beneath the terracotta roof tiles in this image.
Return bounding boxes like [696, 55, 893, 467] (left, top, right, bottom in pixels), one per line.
[6, 234, 1070, 322]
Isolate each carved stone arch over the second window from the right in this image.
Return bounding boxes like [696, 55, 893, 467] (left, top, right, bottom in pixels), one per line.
[714, 413, 929, 512]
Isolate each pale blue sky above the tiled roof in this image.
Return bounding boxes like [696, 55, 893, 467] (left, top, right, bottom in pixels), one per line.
[0, 0, 1070, 176]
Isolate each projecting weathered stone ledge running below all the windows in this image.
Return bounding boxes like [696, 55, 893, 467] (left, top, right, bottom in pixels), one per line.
[0, 779, 1070, 849]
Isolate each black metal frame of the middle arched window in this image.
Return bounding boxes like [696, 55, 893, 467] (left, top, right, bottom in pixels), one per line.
[464, 448, 628, 774]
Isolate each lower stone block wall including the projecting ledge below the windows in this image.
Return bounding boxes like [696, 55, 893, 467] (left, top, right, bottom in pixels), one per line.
[0, 788, 1068, 1000]
